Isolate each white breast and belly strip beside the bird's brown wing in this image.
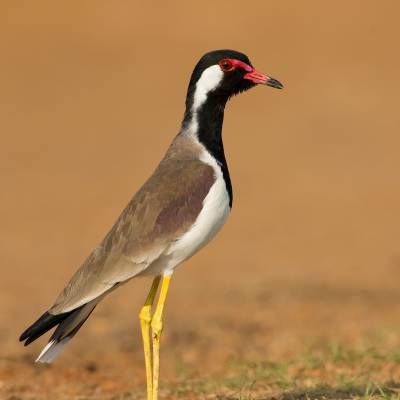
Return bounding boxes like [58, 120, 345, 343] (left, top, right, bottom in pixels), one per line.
[164, 149, 230, 275]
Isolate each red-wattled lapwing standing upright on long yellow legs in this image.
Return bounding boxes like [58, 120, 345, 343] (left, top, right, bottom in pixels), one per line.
[20, 50, 283, 400]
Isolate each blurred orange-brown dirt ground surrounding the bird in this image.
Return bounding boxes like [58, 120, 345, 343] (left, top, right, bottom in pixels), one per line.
[0, 0, 400, 400]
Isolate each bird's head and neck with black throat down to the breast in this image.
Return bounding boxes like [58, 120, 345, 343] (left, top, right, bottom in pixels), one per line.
[181, 50, 283, 205]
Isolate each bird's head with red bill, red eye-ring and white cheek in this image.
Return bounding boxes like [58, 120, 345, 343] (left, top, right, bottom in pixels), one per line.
[188, 50, 283, 109]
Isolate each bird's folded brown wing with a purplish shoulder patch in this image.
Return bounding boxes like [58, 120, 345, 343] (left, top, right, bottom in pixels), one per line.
[50, 145, 215, 314]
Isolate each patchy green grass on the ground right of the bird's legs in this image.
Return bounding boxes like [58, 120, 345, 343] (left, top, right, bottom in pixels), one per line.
[163, 343, 400, 400]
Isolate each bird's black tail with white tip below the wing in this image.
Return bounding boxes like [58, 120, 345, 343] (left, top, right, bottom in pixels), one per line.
[19, 299, 100, 363]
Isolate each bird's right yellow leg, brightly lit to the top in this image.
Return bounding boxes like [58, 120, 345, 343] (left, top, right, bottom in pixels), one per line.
[151, 276, 171, 400]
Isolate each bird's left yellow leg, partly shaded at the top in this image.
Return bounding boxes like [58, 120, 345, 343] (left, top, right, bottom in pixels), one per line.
[139, 276, 161, 400]
